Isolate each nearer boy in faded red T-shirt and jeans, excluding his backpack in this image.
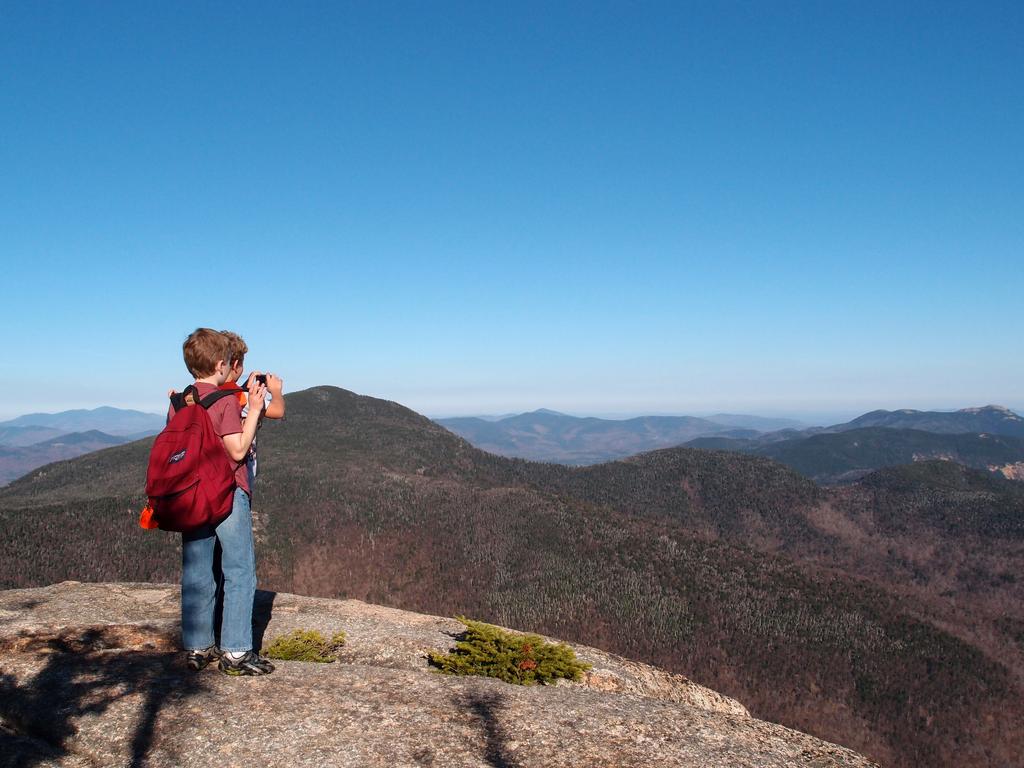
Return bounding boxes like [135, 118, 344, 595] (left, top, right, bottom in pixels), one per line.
[172, 328, 273, 675]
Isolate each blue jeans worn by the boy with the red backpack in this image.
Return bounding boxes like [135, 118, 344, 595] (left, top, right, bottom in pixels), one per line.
[181, 488, 256, 652]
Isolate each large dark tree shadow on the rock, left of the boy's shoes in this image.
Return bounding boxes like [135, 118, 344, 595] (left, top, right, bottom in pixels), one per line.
[0, 626, 203, 768]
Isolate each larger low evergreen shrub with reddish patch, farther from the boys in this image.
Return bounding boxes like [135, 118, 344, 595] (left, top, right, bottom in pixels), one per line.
[427, 616, 591, 685]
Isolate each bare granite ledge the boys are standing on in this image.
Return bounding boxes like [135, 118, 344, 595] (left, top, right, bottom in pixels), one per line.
[0, 582, 873, 768]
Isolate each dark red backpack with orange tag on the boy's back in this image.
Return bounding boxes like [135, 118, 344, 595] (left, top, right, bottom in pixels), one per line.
[139, 385, 236, 531]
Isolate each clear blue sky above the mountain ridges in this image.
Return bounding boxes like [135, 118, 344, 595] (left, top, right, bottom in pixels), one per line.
[0, 2, 1024, 419]
